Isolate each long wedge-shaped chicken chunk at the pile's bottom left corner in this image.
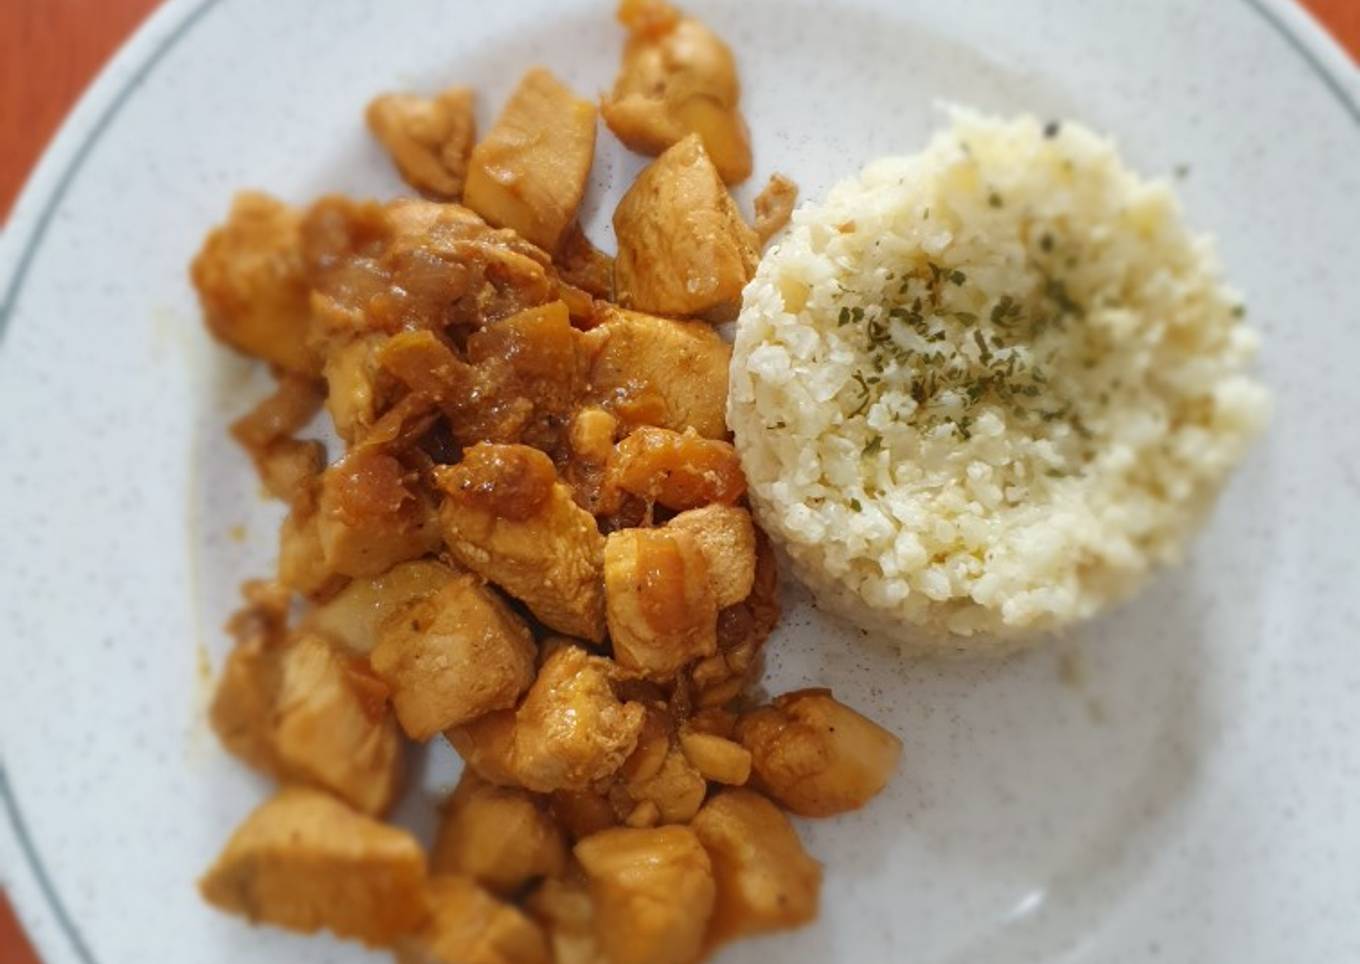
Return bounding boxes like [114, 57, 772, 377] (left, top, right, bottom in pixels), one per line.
[199, 787, 427, 946]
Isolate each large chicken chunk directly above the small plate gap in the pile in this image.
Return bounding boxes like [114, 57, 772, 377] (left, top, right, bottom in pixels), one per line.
[371, 574, 539, 741]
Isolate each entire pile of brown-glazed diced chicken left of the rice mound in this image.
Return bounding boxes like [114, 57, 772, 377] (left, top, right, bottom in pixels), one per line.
[192, 0, 900, 964]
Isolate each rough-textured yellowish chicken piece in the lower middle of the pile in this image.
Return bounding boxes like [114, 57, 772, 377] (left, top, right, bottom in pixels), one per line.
[514, 646, 645, 793]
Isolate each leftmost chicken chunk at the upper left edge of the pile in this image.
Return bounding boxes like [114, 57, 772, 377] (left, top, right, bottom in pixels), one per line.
[190, 192, 321, 375]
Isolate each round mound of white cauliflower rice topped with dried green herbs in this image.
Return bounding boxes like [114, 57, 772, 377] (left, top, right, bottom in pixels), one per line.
[728, 111, 1269, 651]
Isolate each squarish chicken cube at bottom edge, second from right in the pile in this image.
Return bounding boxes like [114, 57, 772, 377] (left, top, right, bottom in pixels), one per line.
[575, 827, 715, 964]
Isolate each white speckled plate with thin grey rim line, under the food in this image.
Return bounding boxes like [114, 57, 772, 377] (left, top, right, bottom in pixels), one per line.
[0, 0, 1360, 964]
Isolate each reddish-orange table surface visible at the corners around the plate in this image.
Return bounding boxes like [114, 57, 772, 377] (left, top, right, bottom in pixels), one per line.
[0, 0, 1360, 964]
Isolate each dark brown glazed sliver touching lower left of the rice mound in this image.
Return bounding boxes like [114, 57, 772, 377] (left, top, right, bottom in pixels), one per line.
[690, 530, 779, 707]
